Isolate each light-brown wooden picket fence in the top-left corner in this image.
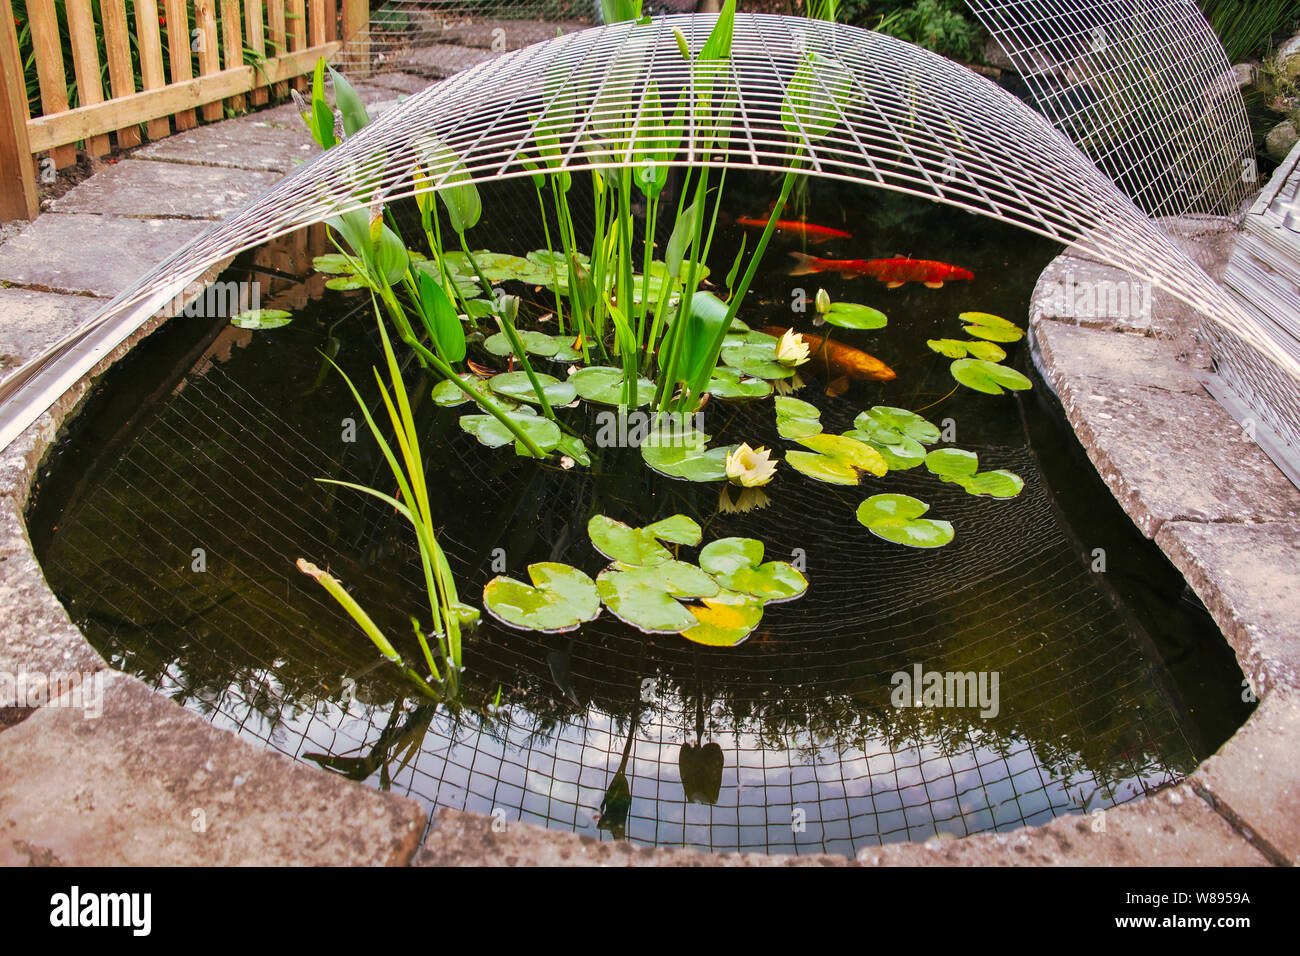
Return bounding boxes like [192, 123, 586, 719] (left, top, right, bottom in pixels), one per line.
[0, 0, 369, 220]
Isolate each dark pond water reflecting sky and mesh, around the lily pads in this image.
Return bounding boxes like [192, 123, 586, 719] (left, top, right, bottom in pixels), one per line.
[29, 174, 1248, 853]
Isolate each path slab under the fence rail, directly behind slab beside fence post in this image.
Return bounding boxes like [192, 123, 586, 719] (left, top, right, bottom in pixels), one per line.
[133, 117, 322, 173]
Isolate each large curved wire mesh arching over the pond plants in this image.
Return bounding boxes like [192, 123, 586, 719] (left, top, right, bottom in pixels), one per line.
[0, 14, 1297, 447]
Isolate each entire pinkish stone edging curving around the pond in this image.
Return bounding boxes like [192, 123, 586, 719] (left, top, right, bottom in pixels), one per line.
[0, 183, 1300, 866]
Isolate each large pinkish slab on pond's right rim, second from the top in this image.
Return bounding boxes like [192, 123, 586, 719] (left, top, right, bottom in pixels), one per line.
[1032, 319, 1300, 537]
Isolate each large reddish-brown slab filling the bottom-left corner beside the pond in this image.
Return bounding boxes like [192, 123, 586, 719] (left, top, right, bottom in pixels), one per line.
[0, 672, 424, 866]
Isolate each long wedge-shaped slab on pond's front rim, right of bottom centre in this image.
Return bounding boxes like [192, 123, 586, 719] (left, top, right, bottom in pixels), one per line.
[857, 786, 1271, 866]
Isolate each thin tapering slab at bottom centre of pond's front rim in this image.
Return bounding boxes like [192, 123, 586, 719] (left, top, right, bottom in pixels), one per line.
[415, 808, 852, 866]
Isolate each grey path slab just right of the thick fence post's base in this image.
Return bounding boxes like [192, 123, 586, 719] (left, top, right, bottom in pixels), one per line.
[51, 159, 281, 219]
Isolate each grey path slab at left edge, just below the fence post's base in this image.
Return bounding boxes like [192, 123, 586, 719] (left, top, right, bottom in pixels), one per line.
[0, 214, 207, 297]
